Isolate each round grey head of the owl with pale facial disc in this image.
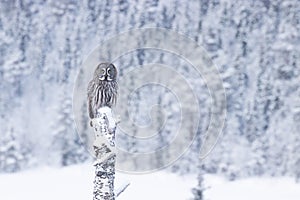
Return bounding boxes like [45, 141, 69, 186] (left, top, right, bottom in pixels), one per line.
[94, 63, 117, 81]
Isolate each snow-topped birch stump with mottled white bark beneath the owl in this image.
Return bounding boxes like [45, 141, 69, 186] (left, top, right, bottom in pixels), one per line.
[91, 107, 116, 200]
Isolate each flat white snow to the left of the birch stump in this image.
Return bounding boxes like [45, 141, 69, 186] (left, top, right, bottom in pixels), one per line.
[0, 166, 93, 200]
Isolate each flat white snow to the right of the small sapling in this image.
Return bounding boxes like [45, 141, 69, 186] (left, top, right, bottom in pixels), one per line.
[204, 176, 300, 200]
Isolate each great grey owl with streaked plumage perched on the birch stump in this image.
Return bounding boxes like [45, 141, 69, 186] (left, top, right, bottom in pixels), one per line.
[87, 63, 118, 119]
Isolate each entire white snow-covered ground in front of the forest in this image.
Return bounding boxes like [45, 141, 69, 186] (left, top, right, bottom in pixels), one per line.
[0, 165, 300, 200]
